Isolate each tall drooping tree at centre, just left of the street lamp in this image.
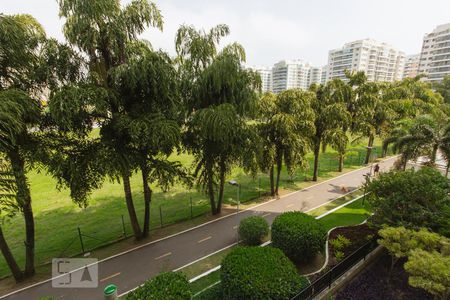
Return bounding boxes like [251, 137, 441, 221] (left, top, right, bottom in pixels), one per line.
[176, 25, 260, 214]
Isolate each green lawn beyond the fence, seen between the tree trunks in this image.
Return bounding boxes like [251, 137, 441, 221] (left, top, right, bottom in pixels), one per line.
[0, 141, 380, 277]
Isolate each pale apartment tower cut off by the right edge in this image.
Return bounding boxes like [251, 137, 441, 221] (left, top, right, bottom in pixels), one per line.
[419, 23, 450, 82]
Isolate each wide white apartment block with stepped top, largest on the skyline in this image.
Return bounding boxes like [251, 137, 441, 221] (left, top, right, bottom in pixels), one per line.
[327, 39, 405, 81]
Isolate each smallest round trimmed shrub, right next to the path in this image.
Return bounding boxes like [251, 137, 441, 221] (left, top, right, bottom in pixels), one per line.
[239, 216, 269, 246]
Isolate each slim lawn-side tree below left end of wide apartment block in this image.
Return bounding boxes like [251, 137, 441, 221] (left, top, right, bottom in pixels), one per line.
[310, 80, 350, 181]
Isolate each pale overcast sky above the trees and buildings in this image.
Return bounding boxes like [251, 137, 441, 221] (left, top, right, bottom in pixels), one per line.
[0, 0, 450, 66]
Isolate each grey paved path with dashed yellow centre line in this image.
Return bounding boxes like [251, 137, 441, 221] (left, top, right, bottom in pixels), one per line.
[0, 158, 395, 300]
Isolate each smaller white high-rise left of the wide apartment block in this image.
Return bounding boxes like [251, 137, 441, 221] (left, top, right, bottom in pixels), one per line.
[272, 60, 311, 94]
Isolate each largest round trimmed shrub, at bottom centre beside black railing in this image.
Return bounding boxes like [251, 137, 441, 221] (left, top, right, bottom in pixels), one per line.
[220, 247, 308, 299]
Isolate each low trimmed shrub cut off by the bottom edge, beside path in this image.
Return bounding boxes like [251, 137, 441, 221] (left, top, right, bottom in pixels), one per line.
[127, 272, 192, 300]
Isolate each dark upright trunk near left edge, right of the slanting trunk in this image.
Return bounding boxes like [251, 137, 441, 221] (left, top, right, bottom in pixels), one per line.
[8, 149, 35, 277]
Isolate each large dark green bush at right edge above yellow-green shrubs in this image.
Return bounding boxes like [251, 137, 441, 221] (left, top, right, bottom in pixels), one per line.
[367, 167, 450, 231]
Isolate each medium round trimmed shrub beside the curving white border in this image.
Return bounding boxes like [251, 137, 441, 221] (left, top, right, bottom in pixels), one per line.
[272, 212, 327, 262]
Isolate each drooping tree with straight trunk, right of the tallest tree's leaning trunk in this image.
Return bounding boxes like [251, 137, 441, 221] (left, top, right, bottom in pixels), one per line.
[111, 45, 187, 236]
